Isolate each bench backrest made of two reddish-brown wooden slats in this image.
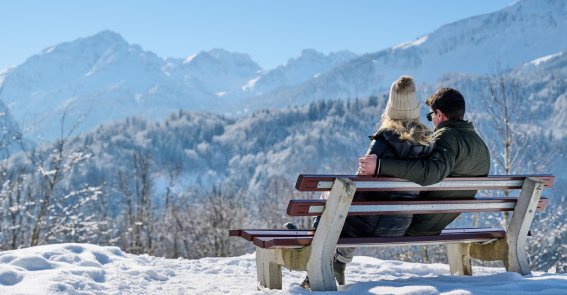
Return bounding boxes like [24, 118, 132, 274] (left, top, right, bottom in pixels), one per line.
[287, 174, 555, 216]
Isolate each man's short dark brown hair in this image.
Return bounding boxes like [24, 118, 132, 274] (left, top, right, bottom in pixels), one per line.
[425, 87, 465, 120]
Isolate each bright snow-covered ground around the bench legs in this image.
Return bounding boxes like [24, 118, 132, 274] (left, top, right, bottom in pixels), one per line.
[0, 244, 567, 295]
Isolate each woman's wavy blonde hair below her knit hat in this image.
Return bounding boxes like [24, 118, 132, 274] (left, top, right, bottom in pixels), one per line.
[377, 113, 433, 145]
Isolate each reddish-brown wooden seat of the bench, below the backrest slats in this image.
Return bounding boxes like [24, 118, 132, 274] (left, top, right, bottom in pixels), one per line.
[250, 228, 506, 249]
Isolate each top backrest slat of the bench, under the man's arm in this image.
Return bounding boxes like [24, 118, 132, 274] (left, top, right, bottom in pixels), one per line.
[295, 174, 555, 192]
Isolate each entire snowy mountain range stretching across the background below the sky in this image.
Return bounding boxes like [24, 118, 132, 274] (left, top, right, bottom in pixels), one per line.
[0, 0, 567, 140]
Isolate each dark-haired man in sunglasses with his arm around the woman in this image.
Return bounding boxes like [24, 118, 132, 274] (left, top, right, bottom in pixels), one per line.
[359, 88, 490, 235]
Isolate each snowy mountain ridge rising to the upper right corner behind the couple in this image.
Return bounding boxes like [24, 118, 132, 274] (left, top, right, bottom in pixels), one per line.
[248, 0, 567, 107]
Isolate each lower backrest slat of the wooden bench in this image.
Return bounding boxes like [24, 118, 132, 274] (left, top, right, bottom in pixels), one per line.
[287, 198, 547, 216]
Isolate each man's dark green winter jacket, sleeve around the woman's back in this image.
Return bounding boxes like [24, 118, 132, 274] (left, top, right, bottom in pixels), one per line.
[378, 120, 490, 235]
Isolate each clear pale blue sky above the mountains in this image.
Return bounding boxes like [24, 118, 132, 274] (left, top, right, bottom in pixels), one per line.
[0, 0, 515, 69]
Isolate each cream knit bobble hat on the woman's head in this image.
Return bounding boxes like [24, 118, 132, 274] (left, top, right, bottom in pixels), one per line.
[384, 76, 419, 120]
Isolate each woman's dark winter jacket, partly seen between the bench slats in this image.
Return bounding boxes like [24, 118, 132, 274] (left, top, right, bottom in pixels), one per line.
[341, 131, 433, 237]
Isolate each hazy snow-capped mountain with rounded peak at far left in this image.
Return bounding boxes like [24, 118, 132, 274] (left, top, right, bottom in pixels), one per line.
[0, 31, 215, 138]
